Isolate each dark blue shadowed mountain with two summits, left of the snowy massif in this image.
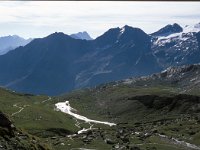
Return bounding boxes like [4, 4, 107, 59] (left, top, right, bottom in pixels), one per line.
[0, 26, 159, 95]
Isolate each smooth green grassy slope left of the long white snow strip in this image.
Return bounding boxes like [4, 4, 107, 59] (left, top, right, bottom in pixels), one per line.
[0, 89, 79, 136]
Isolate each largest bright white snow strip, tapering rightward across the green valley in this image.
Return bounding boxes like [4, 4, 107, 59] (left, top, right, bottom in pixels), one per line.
[55, 101, 116, 126]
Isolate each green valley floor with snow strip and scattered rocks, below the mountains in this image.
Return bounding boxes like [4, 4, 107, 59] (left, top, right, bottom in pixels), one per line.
[0, 80, 200, 150]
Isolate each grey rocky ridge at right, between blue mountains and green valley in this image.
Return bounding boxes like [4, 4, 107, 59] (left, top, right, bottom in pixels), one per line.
[120, 64, 200, 95]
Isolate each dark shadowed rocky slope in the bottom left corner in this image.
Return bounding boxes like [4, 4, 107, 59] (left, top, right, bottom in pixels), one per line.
[0, 112, 49, 150]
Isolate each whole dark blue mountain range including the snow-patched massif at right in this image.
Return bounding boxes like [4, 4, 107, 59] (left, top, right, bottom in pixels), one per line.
[0, 24, 200, 95]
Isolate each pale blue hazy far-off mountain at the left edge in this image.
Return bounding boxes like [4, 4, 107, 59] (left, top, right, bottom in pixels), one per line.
[0, 35, 32, 55]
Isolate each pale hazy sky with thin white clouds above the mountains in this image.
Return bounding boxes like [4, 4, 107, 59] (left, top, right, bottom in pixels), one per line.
[0, 1, 200, 38]
